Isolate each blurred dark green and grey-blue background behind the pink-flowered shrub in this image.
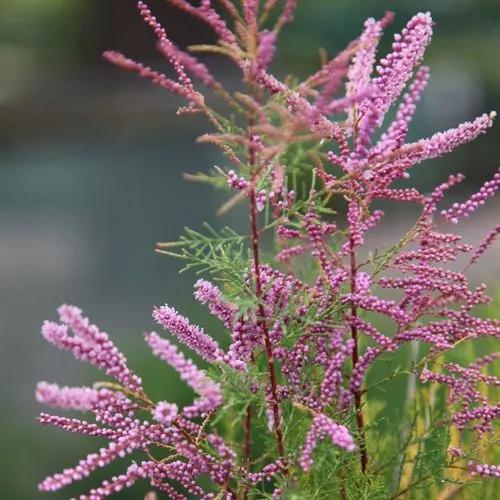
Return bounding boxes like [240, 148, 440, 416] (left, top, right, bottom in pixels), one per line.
[0, 0, 500, 500]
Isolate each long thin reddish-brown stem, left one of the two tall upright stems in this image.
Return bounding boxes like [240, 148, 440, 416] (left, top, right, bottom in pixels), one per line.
[249, 188, 285, 458]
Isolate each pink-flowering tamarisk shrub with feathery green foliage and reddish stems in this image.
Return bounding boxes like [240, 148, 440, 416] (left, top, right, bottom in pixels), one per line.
[36, 0, 500, 499]
